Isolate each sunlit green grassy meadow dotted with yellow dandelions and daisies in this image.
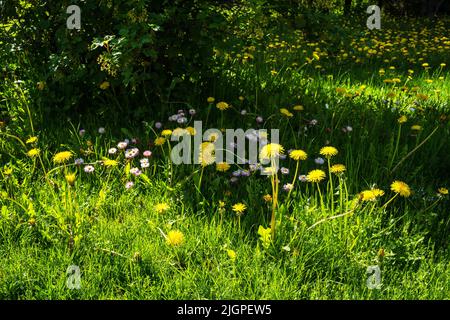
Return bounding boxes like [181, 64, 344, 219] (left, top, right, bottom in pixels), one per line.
[0, 5, 450, 299]
